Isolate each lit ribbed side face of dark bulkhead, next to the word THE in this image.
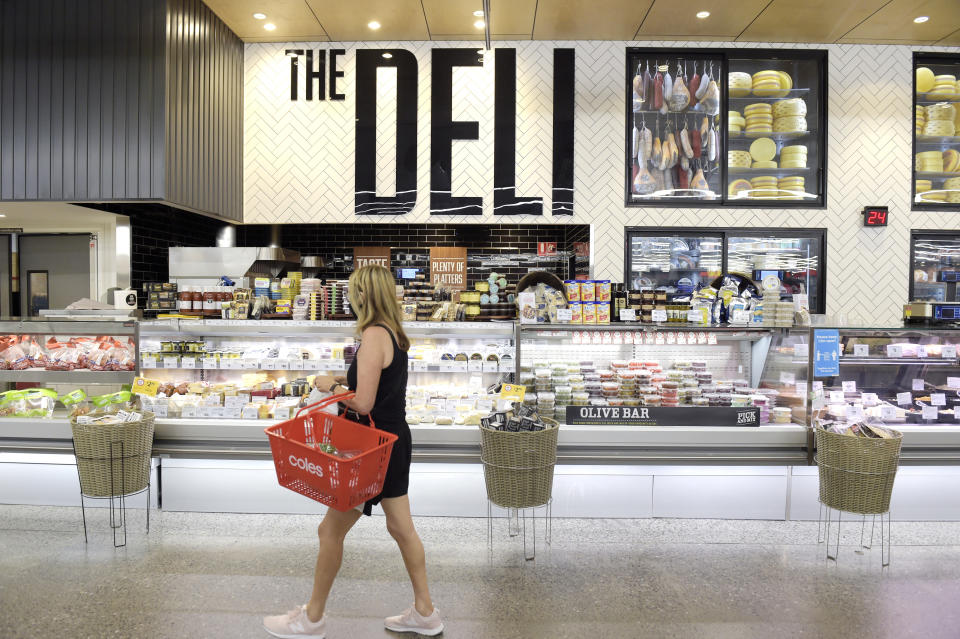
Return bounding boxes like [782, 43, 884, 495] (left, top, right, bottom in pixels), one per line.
[165, 0, 243, 220]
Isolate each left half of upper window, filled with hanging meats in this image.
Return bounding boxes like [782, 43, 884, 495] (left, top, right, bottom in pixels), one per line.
[626, 49, 724, 204]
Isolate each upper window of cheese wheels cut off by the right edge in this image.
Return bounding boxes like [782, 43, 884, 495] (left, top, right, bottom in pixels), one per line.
[912, 52, 960, 211]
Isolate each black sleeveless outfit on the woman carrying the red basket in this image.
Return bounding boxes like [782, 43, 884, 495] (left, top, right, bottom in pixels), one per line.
[347, 324, 413, 516]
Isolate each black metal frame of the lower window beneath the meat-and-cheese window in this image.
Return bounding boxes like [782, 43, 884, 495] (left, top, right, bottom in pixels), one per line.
[623, 226, 828, 314]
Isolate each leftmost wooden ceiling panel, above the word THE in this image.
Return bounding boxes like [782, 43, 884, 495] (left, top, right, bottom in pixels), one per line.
[204, 0, 327, 42]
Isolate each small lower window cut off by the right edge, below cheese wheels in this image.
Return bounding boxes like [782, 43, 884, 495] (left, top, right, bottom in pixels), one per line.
[910, 231, 960, 302]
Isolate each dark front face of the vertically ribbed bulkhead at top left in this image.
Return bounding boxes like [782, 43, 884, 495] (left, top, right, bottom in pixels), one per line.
[0, 0, 166, 201]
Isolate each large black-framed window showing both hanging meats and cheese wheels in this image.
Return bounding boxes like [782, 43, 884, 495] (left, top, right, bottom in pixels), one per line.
[625, 48, 827, 208]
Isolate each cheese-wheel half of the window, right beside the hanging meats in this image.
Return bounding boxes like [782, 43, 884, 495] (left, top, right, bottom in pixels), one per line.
[725, 49, 826, 207]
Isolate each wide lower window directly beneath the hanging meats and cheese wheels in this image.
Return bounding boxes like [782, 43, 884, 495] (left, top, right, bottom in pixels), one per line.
[624, 227, 824, 313]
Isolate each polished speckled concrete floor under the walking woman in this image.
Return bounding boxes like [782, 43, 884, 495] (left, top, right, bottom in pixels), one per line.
[0, 506, 960, 639]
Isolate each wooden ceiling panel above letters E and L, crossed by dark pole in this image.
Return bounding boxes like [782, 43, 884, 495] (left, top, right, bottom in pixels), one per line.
[423, 0, 537, 40]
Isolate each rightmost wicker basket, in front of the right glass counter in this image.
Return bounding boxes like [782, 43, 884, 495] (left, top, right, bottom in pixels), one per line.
[814, 428, 903, 515]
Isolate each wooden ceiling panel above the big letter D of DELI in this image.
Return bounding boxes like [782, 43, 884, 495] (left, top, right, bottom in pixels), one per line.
[306, 0, 430, 41]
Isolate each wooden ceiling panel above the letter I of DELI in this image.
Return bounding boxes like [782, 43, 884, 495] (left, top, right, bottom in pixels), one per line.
[528, 0, 653, 40]
